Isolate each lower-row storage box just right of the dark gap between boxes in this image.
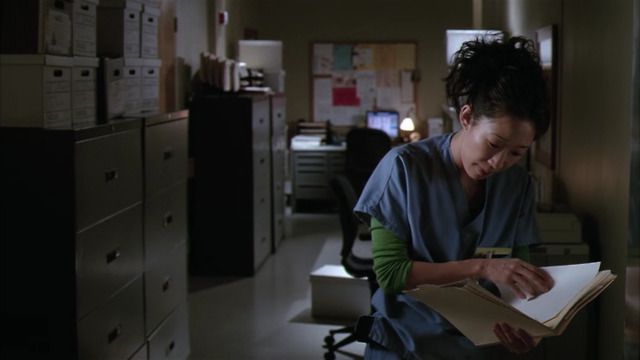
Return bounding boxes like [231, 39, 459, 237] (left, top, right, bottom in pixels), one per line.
[98, 58, 126, 120]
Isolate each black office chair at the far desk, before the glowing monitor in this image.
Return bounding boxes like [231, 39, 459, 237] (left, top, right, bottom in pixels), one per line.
[345, 128, 391, 194]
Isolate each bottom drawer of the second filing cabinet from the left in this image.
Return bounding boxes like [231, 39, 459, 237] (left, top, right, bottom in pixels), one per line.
[149, 301, 190, 360]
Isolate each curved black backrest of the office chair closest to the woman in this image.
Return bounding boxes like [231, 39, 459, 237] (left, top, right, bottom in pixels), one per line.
[329, 175, 375, 281]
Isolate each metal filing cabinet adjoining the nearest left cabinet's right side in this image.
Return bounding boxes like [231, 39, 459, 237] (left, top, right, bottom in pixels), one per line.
[144, 111, 189, 359]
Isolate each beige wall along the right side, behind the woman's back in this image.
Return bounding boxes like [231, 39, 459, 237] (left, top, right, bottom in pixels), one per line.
[482, 0, 633, 359]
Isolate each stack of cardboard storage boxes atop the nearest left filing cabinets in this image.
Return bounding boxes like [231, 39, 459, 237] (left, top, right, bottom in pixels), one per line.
[0, 0, 161, 129]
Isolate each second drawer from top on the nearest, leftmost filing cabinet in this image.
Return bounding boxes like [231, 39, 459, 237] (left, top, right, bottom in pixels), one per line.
[76, 205, 142, 318]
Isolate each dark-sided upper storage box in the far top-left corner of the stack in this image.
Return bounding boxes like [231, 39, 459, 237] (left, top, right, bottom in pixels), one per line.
[0, 0, 73, 55]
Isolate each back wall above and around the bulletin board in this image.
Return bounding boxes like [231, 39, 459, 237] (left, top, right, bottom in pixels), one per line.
[227, 0, 472, 132]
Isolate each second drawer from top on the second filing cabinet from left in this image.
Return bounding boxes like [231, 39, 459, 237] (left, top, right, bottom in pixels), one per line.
[144, 183, 187, 264]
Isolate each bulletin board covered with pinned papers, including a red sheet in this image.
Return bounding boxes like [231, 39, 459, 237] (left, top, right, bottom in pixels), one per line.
[310, 42, 418, 126]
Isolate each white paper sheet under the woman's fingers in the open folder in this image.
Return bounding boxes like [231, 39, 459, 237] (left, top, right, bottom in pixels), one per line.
[498, 262, 600, 322]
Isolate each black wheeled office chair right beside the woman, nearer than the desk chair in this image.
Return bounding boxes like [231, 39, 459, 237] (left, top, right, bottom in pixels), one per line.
[324, 174, 386, 360]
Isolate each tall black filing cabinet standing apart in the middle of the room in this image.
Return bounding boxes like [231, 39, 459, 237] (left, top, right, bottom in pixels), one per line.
[189, 94, 272, 276]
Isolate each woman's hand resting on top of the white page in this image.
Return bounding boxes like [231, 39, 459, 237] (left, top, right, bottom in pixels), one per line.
[480, 259, 553, 299]
